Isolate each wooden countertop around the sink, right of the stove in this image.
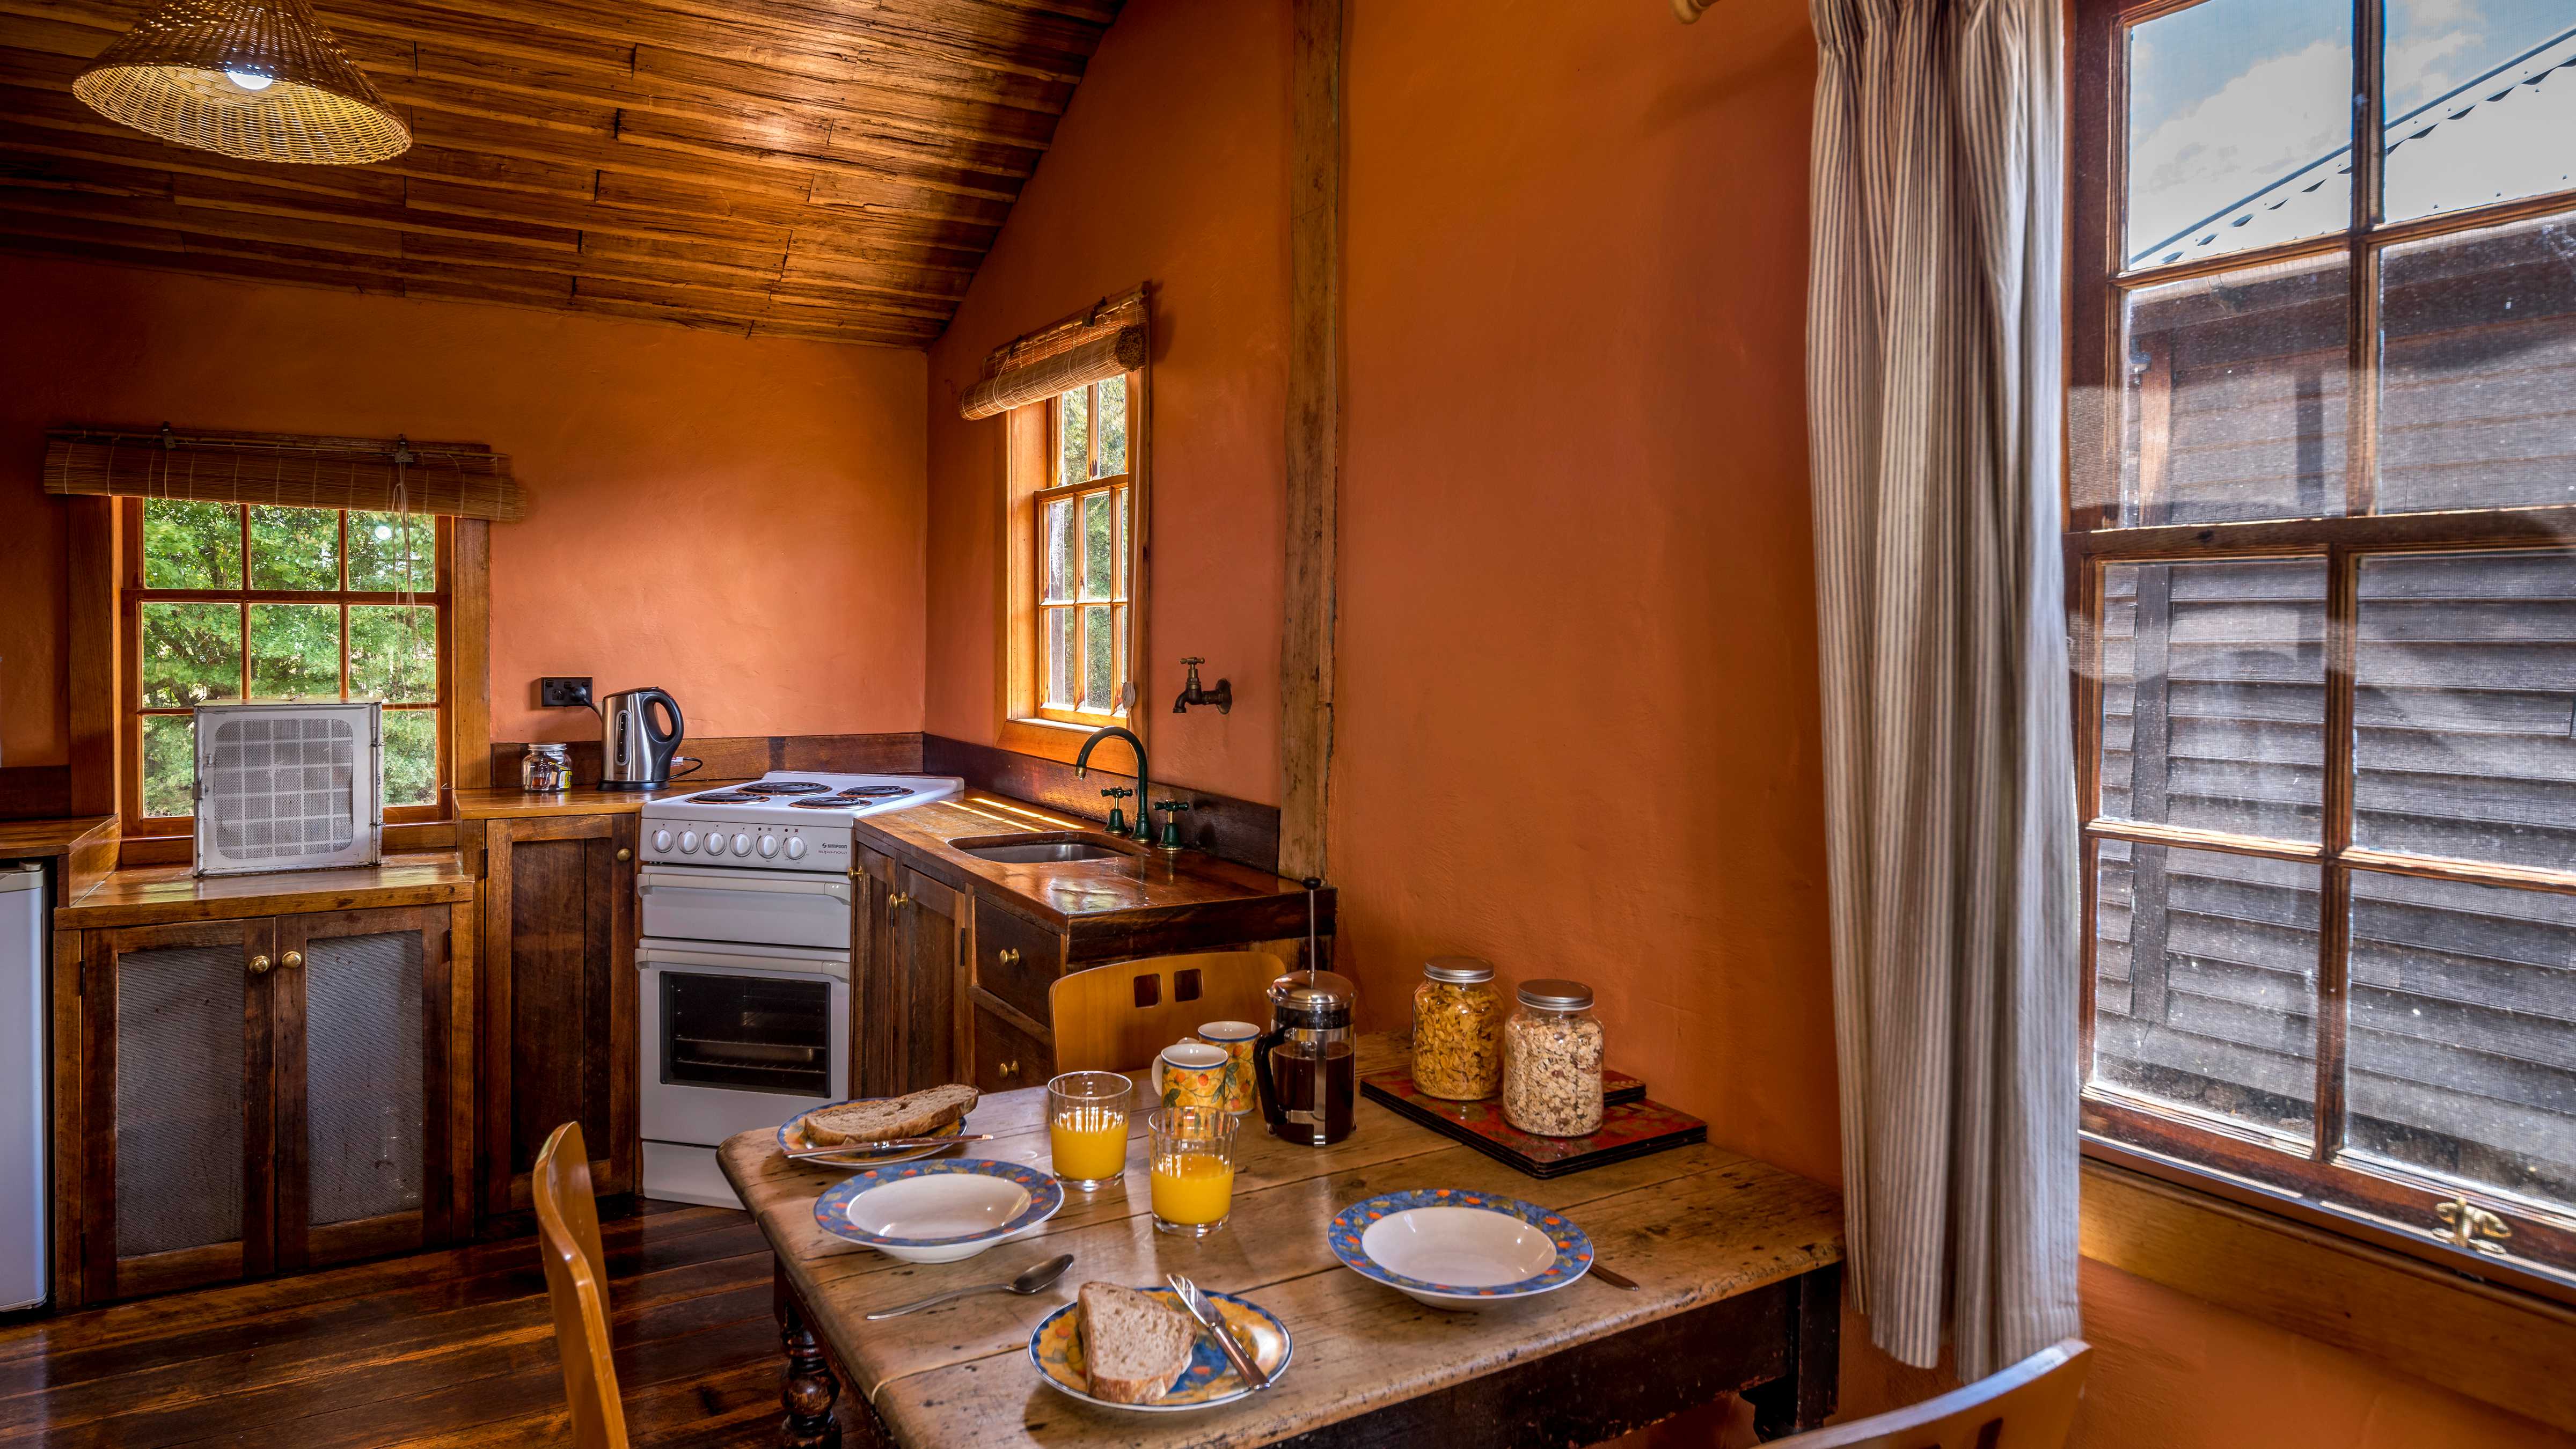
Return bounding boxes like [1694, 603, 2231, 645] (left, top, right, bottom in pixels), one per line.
[858, 789, 1334, 962]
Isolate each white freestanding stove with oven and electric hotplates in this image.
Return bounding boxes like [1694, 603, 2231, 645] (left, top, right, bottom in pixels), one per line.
[636, 771, 963, 1206]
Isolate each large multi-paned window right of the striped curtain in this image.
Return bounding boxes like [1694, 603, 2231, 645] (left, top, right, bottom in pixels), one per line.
[2066, 0, 2576, 1282]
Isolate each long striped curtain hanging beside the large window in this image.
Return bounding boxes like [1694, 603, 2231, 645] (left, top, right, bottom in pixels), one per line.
[1809, 0, 2079, 1379]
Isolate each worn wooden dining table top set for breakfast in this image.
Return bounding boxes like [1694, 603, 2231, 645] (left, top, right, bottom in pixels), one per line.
[719, 1036, 1842, 1449]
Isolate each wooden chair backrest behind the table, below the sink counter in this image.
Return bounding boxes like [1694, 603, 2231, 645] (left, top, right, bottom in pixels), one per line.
[1046, 943, 1296, 1073]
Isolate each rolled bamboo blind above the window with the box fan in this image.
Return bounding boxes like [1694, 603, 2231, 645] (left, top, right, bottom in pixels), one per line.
[44, 428, 528, 523]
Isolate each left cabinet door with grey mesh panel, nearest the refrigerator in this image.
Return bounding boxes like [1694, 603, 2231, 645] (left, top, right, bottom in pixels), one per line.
[79, 920, 276, 1302]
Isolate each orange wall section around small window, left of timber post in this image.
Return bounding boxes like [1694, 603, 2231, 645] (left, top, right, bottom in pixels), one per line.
[927, 0, 1288, 799]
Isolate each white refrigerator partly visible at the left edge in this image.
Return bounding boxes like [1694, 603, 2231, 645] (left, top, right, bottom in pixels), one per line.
[0, 863, 46, 1312]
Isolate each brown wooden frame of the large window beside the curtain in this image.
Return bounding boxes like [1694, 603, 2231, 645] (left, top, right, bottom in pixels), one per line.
[2063, 0, 2576, 1302]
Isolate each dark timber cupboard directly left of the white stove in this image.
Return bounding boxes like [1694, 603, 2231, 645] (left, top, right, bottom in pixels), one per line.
[456, 810, 644, 1214]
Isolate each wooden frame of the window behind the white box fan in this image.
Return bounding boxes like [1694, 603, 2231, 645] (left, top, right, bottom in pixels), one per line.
[64, 497, 492, 866]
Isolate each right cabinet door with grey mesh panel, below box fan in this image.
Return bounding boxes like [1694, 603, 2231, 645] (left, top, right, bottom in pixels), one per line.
[273, 905, 469, 1269]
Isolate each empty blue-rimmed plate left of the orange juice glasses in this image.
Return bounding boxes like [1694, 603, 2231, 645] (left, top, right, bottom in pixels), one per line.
[814, 1158, 1064, 1263]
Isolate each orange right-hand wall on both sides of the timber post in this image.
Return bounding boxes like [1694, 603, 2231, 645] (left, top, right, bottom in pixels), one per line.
[930, 0, 2550, 1449]
